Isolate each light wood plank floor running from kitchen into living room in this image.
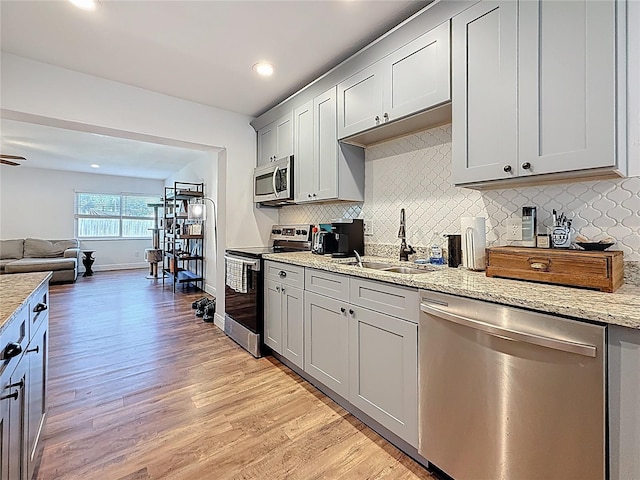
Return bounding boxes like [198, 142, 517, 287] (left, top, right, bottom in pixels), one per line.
[37, 270, 433, 480]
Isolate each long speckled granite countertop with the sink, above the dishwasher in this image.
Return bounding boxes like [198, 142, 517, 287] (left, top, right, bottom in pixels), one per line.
[263, 252, 640, 329]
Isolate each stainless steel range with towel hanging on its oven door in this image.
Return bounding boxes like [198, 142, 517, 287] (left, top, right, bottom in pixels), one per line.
[224, 224, 313, 358]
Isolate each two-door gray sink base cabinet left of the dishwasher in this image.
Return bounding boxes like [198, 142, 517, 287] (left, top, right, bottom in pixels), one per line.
[304, 268, 419, 448]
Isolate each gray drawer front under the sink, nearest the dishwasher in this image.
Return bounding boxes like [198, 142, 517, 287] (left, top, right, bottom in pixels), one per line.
[349, 277, 420, 323]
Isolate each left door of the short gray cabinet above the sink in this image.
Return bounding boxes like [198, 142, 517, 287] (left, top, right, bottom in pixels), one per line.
[338, 63, 384, 138]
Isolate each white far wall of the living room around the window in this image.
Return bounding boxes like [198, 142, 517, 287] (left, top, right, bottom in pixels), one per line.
[0, 166, 163, 271]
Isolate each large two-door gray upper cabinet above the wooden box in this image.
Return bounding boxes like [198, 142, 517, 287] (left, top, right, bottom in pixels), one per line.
[452, 0, 617, 186]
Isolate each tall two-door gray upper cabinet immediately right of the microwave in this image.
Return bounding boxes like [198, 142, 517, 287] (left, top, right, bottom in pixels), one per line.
[293, 87, 364, 203]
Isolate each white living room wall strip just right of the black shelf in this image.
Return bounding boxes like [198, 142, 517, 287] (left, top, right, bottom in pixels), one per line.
[164, 151, 224, 295]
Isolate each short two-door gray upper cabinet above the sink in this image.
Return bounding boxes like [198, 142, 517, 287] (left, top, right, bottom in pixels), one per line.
[338, 22, 451, 139]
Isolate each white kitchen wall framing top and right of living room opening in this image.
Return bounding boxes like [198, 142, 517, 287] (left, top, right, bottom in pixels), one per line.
[0, 52, 278, 324]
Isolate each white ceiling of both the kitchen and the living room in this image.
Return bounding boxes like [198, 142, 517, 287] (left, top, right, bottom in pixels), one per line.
[0, 0, 431, 178]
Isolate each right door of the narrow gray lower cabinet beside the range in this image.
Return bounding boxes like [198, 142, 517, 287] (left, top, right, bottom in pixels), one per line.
[281, 285, 304, 369]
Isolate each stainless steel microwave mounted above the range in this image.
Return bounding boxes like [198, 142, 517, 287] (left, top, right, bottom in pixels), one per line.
[253, 155, 293, 206]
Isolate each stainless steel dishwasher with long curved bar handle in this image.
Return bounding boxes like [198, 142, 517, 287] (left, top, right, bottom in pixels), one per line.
[418, 291, 607, 480]
